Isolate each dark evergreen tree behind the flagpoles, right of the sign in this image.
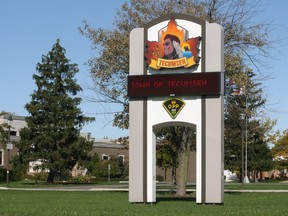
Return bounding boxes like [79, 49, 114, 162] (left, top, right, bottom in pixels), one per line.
[224, 66, 275, 180]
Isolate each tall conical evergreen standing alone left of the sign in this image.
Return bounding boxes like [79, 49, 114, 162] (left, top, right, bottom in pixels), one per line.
[17, 39, 93, 183]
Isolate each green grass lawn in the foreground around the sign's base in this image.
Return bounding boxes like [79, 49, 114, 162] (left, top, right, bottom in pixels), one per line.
[0, 190, 288, 216]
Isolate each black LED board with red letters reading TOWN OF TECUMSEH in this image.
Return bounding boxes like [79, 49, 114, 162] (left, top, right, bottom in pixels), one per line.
[128, 72, 221, 98]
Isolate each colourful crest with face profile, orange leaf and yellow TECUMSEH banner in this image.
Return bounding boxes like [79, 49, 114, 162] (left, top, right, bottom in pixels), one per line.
[145, 17, 201, 70]
